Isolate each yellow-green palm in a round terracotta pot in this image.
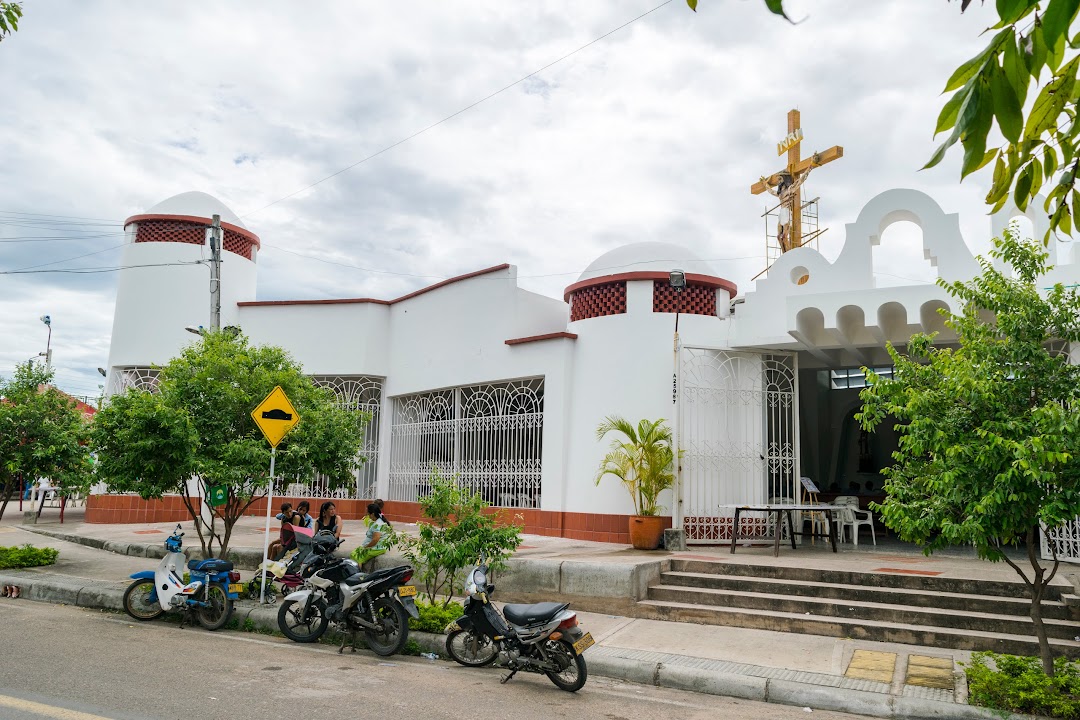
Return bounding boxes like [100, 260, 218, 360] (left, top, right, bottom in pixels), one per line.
[595, 417, 675, 549]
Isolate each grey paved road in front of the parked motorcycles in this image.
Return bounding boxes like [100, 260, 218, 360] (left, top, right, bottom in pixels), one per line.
[0, 599, 856, 720]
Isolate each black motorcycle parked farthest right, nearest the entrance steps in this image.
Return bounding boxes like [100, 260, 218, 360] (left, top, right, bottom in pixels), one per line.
[446, 559, 595, 693]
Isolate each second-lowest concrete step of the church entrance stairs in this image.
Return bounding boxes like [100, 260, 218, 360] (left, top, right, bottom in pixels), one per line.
[648, 585, 1080, 640]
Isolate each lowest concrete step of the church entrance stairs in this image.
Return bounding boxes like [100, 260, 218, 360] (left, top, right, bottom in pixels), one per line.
[637, 599, 1080, 658]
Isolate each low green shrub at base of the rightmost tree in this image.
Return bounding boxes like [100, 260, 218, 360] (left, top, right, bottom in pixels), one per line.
[964, 652, 1080, 718]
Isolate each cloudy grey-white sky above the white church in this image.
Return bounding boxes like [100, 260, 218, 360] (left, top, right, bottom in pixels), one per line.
[0, 0, 994, 395]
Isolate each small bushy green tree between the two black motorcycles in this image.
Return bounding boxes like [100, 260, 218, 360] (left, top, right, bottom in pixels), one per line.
[392, 467, 522, 608]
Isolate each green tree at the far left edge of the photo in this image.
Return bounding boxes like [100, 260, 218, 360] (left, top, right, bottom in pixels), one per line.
[0, 362, 92, 518]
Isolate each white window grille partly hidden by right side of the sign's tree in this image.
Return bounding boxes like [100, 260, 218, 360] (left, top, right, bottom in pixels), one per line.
[284, 375, 382, 500]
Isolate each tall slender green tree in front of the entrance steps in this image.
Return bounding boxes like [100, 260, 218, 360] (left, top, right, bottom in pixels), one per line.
[856, 228, 1080, 675]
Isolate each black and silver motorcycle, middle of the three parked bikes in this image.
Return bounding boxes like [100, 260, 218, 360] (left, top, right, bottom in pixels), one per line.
[278, 535, 419, 655]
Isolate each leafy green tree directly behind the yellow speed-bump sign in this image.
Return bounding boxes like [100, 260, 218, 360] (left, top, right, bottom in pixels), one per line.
[93, 331, 369, 557]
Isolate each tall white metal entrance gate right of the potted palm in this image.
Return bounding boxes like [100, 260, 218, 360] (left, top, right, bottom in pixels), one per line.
[676, 348, 799, 543]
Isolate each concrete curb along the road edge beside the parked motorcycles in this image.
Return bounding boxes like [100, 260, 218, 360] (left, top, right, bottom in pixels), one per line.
[0, 574, 1030, 720]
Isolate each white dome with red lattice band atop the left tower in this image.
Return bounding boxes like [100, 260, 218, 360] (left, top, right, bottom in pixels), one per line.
[124, 192, 260, 261]
